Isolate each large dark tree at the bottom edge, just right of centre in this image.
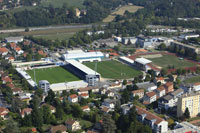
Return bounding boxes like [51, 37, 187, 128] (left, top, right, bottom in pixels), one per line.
[102, 114, 117, 133]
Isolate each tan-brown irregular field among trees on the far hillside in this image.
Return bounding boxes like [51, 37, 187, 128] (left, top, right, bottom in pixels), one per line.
[103, 5, 143, 22]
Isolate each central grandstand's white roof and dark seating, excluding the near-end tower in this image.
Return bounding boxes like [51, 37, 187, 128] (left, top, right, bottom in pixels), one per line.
[64, 60, 101, 80]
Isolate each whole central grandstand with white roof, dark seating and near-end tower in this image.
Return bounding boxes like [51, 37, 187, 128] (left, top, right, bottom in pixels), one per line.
[64, 60, 101, 86]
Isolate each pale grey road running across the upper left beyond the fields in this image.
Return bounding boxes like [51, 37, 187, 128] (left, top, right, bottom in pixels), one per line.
[0, 24, 105, 33]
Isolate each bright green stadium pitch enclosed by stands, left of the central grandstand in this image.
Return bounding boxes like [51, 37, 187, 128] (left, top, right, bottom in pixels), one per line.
[26, 67, 80, 84]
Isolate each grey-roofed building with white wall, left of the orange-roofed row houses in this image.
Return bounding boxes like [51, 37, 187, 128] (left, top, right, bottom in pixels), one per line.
[136, 82, 157, 92]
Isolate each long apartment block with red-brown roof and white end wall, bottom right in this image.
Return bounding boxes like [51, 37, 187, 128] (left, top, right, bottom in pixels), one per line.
[136, 106, 168, 133]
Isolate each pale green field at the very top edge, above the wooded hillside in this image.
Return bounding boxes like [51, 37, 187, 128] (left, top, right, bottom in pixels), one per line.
[40, 0, 84, 7]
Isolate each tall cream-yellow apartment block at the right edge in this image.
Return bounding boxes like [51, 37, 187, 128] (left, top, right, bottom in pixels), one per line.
[177, 92, 200, 117]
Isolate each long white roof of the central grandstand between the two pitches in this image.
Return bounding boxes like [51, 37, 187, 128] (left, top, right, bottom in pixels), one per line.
[67, 60, 100, 75]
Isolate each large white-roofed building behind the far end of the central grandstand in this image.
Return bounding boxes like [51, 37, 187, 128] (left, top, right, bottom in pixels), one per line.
[62, 50, 104, 62]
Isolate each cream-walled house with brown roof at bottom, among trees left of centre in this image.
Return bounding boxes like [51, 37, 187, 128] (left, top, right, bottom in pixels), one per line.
[65, 119, 81, 131]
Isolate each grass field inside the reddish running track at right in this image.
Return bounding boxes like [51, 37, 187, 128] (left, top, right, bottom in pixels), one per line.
[146, 55, 196, 68]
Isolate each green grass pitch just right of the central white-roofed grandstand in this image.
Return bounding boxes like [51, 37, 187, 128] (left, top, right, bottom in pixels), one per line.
[84, 60, 142, 79]
